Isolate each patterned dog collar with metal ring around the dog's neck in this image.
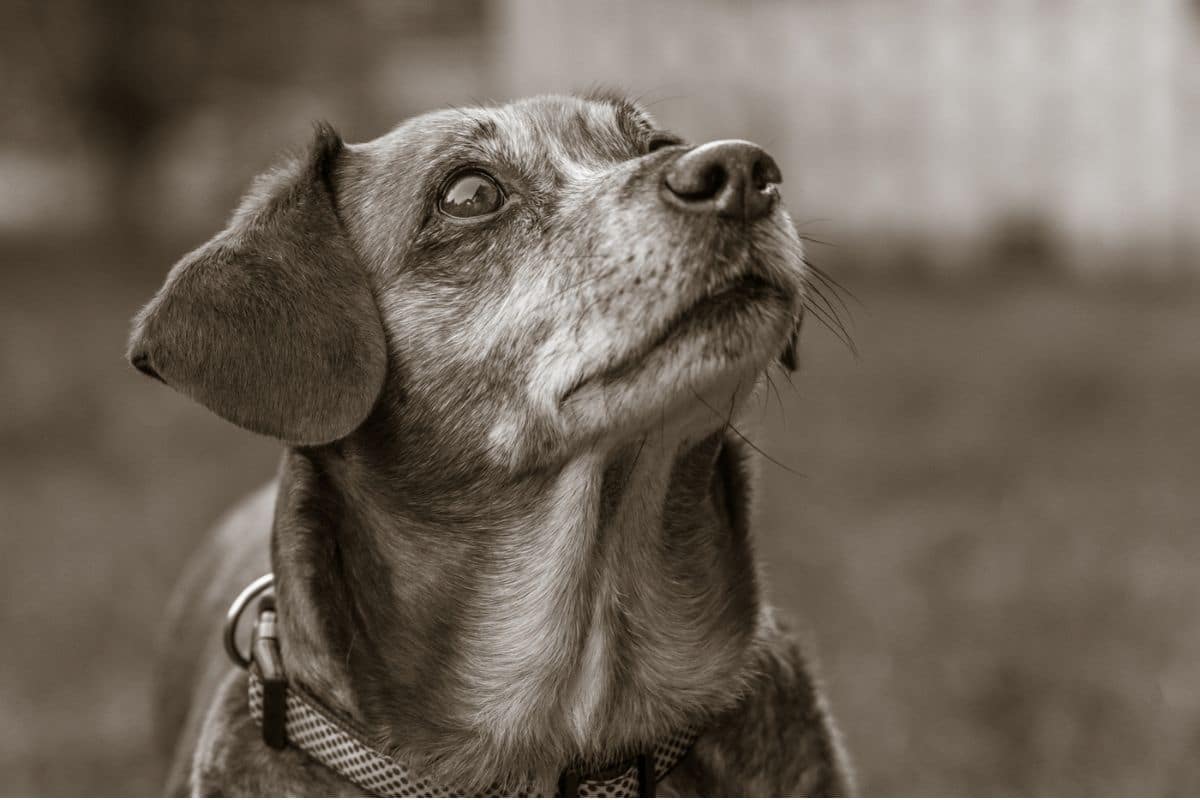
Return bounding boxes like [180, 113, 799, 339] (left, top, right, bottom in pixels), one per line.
[224, 575, 698, 798]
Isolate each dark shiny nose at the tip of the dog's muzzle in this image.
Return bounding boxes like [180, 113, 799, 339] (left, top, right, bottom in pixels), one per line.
[662, 139, 784, 222]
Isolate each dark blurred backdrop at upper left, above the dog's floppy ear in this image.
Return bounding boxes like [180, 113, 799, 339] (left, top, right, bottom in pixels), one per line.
[0, 0, 490, 242]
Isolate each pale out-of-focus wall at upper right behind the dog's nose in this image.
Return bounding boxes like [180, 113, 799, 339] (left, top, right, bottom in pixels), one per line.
[493, 0, 1200, 277]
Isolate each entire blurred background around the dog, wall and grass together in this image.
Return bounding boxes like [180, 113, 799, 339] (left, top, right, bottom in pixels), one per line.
[0, 0, 1200, 795]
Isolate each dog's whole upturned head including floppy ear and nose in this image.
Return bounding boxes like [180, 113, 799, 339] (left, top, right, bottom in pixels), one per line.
[130, 97, 804, 470]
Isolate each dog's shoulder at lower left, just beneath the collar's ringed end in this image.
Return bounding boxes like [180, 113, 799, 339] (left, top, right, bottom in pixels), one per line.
[187, 668, 362, 798]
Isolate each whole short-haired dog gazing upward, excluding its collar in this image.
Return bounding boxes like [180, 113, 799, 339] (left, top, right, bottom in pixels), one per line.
[127, 92, 853, 795]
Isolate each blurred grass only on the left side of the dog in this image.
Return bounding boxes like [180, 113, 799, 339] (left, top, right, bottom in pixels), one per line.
[0, 235, 277, 794]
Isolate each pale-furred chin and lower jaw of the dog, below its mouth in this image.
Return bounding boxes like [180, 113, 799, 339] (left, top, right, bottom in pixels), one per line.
[559, 278, 794, 443]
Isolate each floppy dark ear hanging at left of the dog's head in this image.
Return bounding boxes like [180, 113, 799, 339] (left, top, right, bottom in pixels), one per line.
[127, 126, 386, 445]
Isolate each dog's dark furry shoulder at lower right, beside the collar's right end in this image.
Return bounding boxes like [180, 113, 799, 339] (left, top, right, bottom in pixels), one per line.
[672, 621, 853, 796]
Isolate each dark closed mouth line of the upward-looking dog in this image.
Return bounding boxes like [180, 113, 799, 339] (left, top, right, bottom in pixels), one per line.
[559, 272, 791, 403]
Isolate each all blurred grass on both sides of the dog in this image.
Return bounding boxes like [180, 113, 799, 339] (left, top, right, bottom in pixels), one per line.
[0, 241, 1200, 795]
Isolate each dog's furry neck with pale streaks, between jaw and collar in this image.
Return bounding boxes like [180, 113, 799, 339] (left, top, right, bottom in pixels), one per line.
[272, 402, 761, 793]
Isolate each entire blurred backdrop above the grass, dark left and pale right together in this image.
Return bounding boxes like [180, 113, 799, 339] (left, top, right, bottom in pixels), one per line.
[0, 0, 1200, 281]
